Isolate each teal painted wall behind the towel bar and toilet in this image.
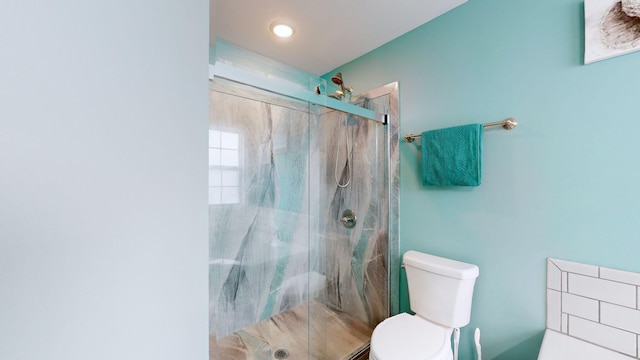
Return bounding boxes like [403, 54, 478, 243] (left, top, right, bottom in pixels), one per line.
[337, 0, 640, 360]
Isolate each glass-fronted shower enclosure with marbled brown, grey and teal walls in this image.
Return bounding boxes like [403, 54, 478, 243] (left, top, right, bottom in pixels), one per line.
[209, 58, 398, 360]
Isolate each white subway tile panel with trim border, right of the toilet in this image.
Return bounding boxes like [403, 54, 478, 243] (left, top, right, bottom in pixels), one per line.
[547, 258, 640, 358]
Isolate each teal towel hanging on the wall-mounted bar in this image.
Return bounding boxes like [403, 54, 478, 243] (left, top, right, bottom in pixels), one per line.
[422, 124, 484, 186]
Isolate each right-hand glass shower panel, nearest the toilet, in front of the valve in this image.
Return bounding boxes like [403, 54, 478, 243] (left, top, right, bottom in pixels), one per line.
[310, 105, 389, 359]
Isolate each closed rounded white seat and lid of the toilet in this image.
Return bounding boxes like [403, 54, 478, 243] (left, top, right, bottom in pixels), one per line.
[369, 313, 453, 360]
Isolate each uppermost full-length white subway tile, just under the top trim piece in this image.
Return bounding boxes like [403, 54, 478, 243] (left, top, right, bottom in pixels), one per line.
[568, 274, 637, 307]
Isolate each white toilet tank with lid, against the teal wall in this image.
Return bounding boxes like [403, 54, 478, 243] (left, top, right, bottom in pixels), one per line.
[403, 250, 480, 328]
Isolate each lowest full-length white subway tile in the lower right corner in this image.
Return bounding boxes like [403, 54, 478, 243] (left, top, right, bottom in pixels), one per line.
[569, 316, 638, 356]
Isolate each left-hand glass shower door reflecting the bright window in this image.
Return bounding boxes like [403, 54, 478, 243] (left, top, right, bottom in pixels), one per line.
[209, 79, 316, 359]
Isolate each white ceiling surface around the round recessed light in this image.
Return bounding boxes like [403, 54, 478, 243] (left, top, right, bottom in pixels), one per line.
[209, 0, 466, 75]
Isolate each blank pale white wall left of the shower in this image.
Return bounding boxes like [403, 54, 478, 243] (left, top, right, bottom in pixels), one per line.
[0, 0, 209, 360]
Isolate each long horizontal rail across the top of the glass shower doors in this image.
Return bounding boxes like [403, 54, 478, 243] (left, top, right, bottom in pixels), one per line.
[209, 61, 385, 124]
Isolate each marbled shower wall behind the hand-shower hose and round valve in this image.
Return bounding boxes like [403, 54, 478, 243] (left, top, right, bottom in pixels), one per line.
[318, 105, 389, 328]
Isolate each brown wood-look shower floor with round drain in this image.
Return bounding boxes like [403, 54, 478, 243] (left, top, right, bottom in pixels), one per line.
[209, 301, 373, 360]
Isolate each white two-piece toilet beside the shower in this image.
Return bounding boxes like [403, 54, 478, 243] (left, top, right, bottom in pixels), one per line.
[369, 251, 479, 360]
